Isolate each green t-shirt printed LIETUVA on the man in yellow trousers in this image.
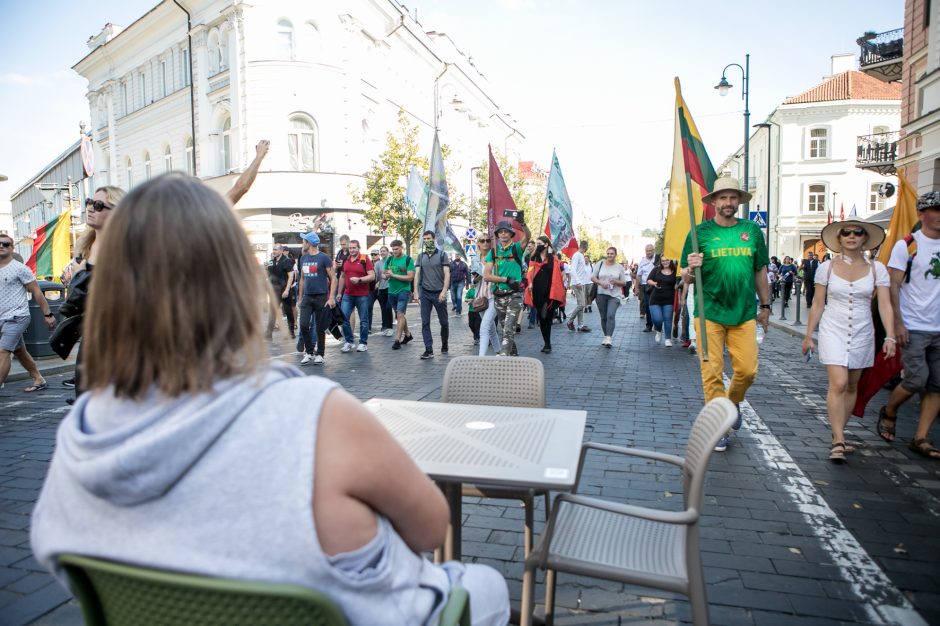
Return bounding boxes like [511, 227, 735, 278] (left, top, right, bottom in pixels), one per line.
[681, 219, 770, 326]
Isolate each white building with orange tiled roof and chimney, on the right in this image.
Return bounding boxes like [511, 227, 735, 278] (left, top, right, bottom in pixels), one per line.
[718, 55, 901, 258]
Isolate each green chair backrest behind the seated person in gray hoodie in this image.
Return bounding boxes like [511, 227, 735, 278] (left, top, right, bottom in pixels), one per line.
[58, 554, 347, 626]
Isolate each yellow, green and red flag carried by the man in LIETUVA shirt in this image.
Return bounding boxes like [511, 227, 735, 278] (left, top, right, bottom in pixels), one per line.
[663, 77, 717, 261]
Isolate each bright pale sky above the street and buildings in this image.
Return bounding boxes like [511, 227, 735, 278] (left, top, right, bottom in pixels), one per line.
[0, 0, 904, 226]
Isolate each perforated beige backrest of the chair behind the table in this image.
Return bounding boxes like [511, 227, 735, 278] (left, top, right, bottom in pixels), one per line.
[441, 356, 545, 407]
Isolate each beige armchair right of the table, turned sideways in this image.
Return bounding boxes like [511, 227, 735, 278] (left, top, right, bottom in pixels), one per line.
[521, 398, 737, 626]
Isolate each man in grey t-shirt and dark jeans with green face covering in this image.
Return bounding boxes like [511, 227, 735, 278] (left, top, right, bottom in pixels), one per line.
[415, 230, 450, 359]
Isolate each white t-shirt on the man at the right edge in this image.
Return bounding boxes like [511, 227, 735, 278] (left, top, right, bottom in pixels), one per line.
[888, 231, 940, 333]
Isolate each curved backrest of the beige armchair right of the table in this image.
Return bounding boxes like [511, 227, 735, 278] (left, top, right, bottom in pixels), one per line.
[683, 398, 738, 513]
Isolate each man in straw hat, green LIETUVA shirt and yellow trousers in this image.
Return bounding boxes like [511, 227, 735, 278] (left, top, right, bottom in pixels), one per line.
[681, 177, 770, 452]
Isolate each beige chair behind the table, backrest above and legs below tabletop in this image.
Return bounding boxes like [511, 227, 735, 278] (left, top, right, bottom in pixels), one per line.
[441, 356, 551, 557]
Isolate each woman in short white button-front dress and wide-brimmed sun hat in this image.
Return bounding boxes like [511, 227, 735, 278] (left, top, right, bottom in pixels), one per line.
[803, 220, 897, 463]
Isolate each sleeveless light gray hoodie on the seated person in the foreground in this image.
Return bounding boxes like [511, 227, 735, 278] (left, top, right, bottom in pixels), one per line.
[31, 364, 453, 624]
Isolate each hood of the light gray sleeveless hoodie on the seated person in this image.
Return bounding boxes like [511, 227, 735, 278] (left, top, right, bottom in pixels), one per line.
[56, 362, 303, 506]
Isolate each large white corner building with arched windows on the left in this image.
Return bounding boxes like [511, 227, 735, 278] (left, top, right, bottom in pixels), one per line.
[74, 0, 523, 257]
